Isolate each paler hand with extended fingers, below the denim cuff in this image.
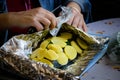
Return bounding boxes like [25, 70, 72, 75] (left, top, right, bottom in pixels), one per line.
[67, 2, 87, 32]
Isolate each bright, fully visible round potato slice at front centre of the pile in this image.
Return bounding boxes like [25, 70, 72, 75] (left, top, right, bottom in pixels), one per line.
[57, 52, 68, 65]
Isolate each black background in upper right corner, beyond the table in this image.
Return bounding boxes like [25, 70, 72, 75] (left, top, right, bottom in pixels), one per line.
[90, 0, 120, 21]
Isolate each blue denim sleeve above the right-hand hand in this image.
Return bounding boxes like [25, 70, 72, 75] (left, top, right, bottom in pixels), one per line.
[62, 0, 92, 23]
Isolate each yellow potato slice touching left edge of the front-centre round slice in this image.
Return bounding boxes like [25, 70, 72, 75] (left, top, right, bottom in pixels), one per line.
[44, 49, 58, 60]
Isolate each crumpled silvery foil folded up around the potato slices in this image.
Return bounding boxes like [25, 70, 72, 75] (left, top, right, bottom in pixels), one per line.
[0, 23, 108, 80]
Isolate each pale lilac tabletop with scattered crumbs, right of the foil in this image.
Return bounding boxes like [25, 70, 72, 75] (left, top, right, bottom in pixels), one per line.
[81, 18, 120, 80]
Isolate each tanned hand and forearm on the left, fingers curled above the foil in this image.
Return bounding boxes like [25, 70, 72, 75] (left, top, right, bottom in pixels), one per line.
[9, 7, 57, 31]
